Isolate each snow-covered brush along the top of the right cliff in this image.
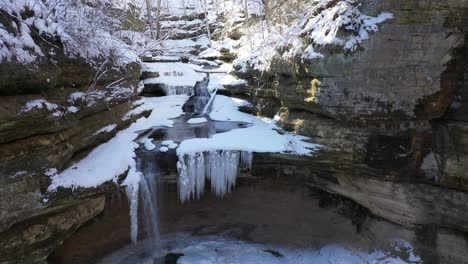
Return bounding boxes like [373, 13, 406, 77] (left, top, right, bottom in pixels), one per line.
[232, 0, 393, 73]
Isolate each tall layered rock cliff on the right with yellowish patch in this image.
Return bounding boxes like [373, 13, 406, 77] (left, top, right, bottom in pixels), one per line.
[244, 0, 468, 263]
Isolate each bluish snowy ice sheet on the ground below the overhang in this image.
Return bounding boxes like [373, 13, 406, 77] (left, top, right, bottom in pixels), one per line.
[165, 236, 421, 264]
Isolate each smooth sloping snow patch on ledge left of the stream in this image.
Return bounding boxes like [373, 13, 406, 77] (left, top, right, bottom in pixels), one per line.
[48, 95, 188, 191]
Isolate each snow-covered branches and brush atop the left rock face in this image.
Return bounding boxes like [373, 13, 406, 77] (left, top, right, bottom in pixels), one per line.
[0, 0, 139, 67]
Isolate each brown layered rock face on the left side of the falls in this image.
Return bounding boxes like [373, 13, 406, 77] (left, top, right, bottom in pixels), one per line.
[0, 35, 144, 263]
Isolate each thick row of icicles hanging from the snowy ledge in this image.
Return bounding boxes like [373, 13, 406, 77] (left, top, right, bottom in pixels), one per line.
[177, 150, 253, 202]
